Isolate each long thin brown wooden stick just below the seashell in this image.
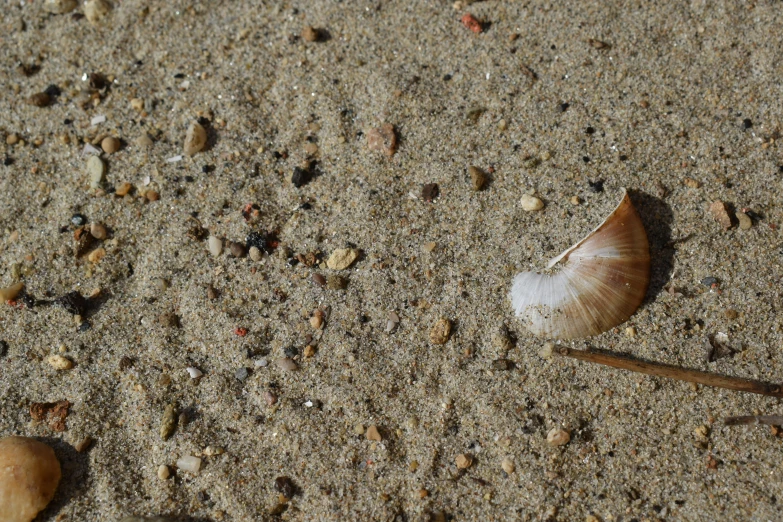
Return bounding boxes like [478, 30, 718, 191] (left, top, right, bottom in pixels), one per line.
[553, 346, 783, 398]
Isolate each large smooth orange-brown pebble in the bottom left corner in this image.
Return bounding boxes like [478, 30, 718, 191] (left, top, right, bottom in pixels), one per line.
[0, 437, 61, 522]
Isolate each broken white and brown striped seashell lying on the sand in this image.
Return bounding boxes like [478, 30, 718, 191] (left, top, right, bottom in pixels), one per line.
[509, 189, 650, 339]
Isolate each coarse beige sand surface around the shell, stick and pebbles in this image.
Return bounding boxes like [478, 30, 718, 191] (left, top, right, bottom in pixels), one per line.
[0, 0, 783, 521]
